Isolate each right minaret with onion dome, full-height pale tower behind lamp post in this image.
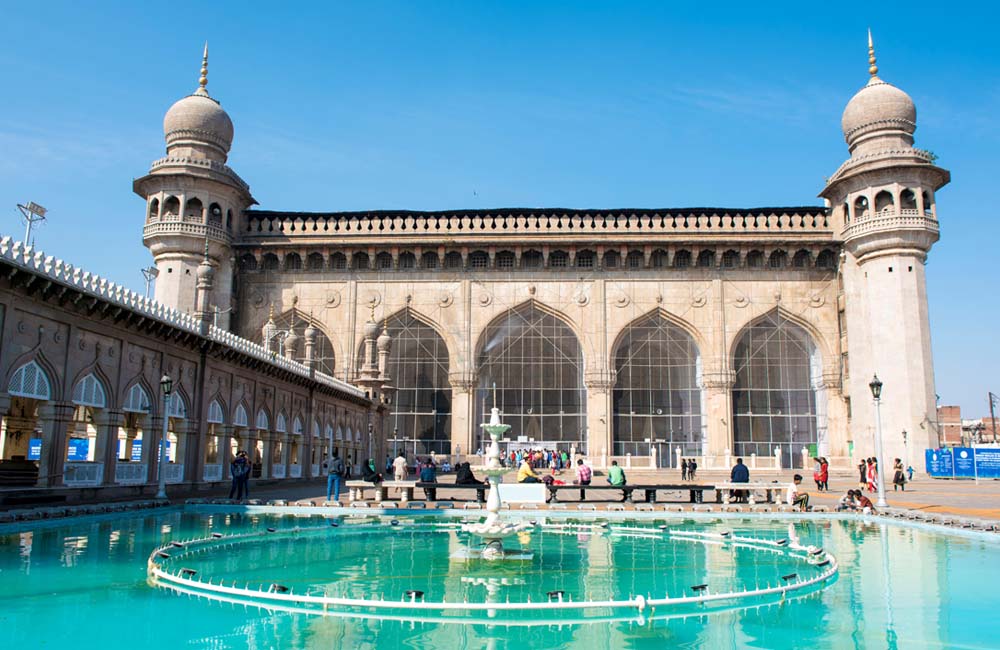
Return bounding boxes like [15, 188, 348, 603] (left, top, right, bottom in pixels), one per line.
[820, 32, 950, 466]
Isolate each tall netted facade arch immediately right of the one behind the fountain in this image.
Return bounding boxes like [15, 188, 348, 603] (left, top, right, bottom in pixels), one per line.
[612, 313, 705, 460]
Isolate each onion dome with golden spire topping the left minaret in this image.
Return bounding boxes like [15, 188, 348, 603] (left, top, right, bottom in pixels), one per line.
[163, 43, 233, 162]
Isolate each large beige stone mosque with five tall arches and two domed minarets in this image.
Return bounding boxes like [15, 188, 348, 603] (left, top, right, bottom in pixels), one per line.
[134, 39, 950, 468]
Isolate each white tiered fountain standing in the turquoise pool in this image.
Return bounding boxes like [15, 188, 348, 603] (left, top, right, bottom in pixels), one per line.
[462, 398, 532, 560]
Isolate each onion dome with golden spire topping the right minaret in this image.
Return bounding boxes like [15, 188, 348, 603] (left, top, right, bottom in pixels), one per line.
[841, 30, 917, 156]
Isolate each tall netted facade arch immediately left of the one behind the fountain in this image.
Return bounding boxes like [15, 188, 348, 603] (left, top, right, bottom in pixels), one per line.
[378, 309, 451, 454]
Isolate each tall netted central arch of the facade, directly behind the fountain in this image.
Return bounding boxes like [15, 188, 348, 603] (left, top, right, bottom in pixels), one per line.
[475, 302, 587, 453]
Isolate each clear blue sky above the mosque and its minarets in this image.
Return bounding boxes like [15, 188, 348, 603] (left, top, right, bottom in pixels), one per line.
[0, 2, 1000, 416]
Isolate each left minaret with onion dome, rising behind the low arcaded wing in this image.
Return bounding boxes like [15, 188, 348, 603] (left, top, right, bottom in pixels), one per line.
[132, 43, 256, 329]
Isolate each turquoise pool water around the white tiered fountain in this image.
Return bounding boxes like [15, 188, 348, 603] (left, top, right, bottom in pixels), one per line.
[0, 511, 1000, 649]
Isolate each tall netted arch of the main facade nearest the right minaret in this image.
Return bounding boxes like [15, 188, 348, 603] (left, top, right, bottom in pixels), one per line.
[733, 313, 826, 467]
